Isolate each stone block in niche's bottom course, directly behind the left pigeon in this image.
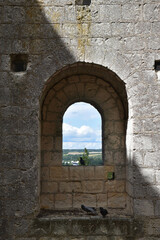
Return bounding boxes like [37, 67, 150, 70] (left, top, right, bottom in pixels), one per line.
[73, 193, 96, 208]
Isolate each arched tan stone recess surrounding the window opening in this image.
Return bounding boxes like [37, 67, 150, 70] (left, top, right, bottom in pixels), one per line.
[40, 64, 130, 216]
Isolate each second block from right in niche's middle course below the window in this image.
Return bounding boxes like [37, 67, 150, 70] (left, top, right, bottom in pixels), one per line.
[82, 180, 104, 193]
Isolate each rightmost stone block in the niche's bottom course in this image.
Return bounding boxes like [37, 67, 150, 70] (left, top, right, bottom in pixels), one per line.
[108, 193, 126, 208]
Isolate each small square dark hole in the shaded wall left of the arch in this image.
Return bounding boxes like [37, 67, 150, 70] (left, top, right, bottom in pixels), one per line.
[11, 54, 28, 72]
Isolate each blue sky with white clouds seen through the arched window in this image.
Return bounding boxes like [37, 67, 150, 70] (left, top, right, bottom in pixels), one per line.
[63, 102, 102, 149]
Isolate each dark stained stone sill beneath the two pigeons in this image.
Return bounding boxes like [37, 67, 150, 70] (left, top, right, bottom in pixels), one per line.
[30, 214, 142, 240]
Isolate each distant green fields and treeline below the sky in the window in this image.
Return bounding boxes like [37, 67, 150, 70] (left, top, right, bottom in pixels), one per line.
[62, 149, 103, 166]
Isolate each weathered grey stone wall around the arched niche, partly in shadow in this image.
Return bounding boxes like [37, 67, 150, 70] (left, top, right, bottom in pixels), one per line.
[0, 0, 160, 240]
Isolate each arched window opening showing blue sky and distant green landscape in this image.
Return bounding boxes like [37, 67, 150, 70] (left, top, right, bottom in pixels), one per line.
[62, 102, 103, 166]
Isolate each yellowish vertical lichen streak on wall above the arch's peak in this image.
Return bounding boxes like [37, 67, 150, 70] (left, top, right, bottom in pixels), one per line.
[76, 7, 91, 60]
